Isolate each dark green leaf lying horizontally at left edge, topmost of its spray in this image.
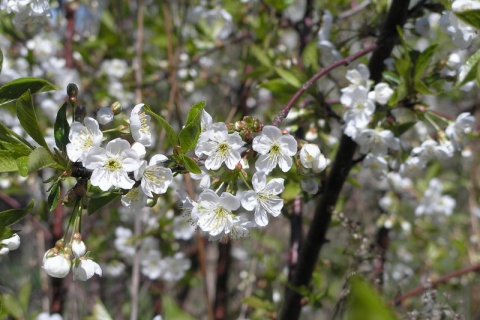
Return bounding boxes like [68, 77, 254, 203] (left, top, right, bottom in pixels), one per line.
[0, 77, 57, 102]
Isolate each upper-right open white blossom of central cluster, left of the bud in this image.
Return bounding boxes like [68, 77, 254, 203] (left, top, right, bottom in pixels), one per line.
[252, 126, 297, 174]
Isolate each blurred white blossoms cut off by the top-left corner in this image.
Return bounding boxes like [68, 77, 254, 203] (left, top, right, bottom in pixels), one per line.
[0, 0, 50, 27]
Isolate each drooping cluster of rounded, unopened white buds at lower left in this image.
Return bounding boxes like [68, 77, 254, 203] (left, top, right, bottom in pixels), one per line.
[43, 233, 102, 281]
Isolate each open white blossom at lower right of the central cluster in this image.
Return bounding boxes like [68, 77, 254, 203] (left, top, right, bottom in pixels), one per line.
[242, 171, 284, 227]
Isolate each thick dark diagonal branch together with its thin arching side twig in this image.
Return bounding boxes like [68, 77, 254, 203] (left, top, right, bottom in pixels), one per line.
[280, 0, 409, 320]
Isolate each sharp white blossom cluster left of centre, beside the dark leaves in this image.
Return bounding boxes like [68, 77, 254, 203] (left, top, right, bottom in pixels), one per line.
[67, 104, 173, 210]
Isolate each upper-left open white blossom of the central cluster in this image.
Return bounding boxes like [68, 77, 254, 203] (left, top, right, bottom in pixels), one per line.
[195, 122, 244, 170]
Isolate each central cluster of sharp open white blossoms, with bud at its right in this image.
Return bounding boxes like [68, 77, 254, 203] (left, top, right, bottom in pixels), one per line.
[179, 111, 328, 240]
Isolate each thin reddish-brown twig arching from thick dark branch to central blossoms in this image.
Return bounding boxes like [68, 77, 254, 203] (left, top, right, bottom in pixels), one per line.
[272, 44, 378, 127]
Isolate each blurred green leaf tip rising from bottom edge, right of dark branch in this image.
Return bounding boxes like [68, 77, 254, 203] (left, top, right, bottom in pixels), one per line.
[346, 276, 395, 320]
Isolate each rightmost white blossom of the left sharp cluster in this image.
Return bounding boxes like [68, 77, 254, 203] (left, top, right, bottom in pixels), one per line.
[135, 154, 173, 198]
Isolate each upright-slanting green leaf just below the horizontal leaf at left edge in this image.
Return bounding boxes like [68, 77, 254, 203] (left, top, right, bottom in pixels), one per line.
[15, 91, 48, 150]
